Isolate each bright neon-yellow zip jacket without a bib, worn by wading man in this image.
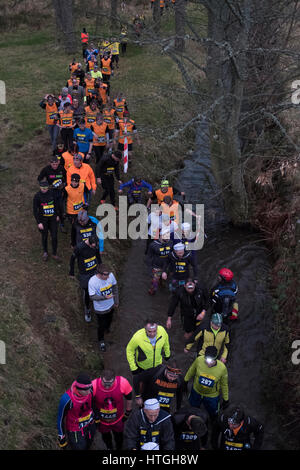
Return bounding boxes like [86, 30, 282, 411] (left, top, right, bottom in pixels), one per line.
[126, 325, 171, 371]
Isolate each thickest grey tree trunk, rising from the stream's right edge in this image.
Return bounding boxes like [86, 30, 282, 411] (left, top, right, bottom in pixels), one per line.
[207, 0, 251, 225]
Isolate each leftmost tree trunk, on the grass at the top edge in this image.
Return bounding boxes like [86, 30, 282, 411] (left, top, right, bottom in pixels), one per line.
[53, 0, 76, 54]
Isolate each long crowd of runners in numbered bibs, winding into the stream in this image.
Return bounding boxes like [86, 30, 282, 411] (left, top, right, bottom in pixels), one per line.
[33, 12, 264, 452]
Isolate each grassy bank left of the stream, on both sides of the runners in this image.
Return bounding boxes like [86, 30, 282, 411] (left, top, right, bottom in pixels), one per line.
[0, 6, 202, 449]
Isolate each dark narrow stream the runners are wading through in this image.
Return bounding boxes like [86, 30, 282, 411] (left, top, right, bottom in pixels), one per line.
[88, 119, 277, 450]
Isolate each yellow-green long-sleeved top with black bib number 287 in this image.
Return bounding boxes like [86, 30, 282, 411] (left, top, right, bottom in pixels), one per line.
[184, 356, 228, 400]
